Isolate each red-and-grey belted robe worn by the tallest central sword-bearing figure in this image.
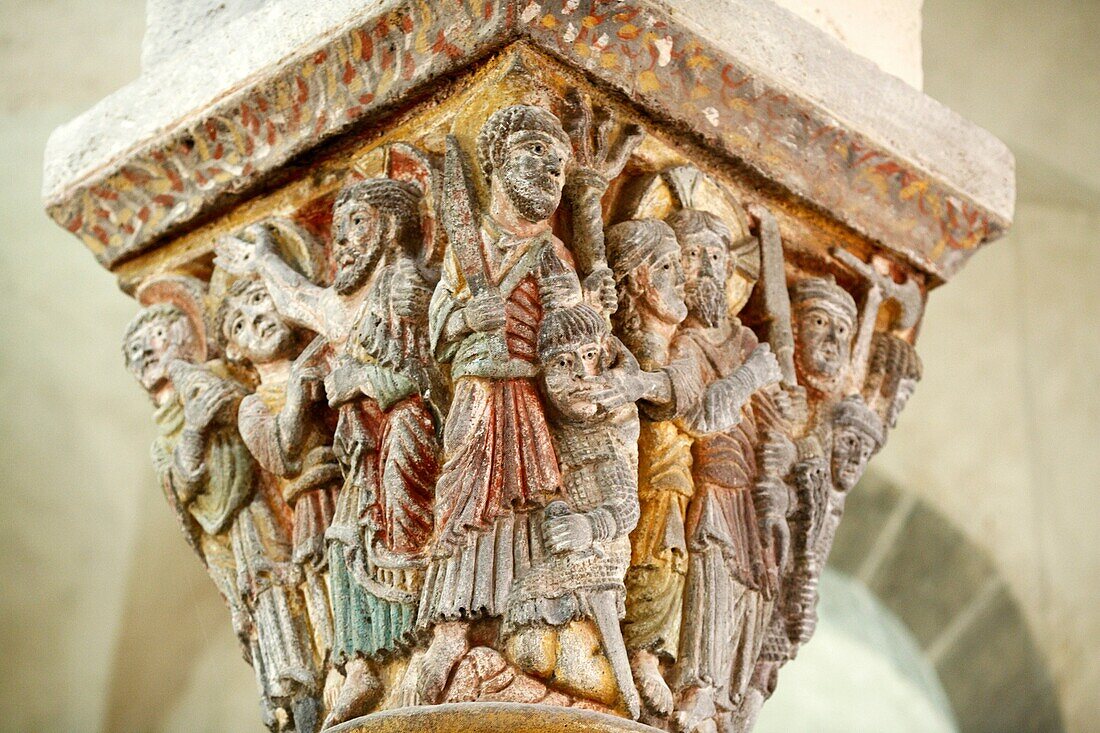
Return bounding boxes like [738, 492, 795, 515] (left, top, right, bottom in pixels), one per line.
[419, 221, 580, 625]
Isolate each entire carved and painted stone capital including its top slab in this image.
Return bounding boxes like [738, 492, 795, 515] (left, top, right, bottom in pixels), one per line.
[44, 0, 1014, 733]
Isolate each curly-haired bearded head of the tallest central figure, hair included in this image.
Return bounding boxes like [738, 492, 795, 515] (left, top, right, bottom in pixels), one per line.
[477, 105, 573, 222]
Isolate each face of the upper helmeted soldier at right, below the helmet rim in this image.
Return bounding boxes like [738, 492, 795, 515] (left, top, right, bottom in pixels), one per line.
[794, 300, 853, 392]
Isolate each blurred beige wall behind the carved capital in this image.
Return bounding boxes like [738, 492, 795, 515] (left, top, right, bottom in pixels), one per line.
[0, 0, 1100, 733]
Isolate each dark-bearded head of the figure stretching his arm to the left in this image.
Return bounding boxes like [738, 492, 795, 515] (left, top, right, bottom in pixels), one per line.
[332, 178, 422, 295]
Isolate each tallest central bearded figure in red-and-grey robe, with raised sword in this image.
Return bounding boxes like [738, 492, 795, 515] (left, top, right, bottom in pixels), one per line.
[418, 105, 581, 702]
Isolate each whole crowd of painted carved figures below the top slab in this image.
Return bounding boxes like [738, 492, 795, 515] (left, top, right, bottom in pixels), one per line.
[124, 94, 921, 733]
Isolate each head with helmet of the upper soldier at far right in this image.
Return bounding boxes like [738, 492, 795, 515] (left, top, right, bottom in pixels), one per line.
[791, 277, 856, 392]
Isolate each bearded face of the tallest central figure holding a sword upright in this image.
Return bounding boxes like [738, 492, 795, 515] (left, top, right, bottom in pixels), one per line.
[493, 130, 572, 221]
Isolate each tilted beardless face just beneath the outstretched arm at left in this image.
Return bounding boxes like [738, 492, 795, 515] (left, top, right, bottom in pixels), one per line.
[222, 282, 294, 364]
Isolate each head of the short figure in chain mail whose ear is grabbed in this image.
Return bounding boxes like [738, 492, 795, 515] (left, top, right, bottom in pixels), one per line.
[539, 304, 607, 417]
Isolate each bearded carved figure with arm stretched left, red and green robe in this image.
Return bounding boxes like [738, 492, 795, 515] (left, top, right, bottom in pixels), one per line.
[212, 172, 441, 725]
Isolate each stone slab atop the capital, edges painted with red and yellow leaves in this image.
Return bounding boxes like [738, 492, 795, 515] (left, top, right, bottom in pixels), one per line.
[44, 0, 1014, 277]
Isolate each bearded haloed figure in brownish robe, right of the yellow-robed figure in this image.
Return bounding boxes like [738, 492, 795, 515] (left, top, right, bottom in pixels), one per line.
[669, 193, 789, 731]
